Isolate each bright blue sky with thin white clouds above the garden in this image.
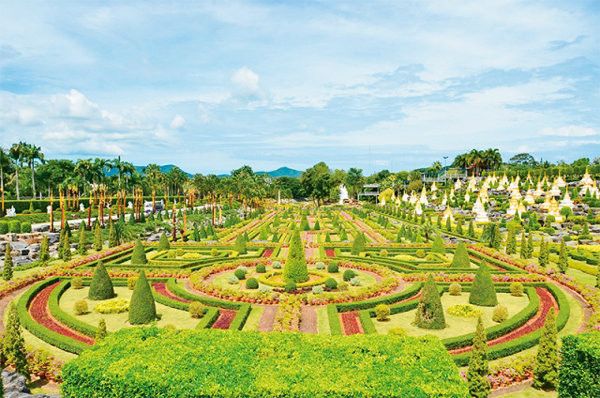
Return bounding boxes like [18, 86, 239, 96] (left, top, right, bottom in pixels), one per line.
[0, 0, 600, 173]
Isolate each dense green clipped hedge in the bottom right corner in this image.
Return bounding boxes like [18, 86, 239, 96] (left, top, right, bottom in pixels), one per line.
[558, 331, 600, 398]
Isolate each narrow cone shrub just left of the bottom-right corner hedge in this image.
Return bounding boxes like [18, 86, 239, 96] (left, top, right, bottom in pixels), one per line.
[533, 308, 560, 389]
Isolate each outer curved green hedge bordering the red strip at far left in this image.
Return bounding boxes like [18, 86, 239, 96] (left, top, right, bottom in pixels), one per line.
[17, 278, 89, 354]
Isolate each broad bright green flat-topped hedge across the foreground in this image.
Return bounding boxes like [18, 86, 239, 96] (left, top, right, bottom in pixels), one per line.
[62, 327, 468, 398]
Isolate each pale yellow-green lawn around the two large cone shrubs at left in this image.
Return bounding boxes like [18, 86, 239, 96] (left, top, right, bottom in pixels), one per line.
[60, 287, 198, 332]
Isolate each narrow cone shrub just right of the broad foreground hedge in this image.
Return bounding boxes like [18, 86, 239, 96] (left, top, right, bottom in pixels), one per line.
[467, 318, 492, 398]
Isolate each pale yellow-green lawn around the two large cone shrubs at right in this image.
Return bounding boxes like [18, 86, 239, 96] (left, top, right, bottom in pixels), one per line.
[373, 292, 529, 339]
